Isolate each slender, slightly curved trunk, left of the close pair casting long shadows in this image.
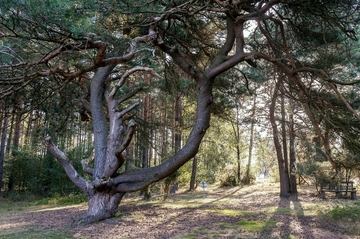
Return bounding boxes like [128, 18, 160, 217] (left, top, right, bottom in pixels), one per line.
[270, 81, 289, 197]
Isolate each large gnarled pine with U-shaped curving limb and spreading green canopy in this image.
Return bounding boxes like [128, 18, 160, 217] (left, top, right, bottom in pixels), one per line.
[0, 0, 358, 222]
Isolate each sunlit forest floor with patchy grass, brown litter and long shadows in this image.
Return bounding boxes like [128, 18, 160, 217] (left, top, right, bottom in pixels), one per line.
[0, 182, 360, 239]
